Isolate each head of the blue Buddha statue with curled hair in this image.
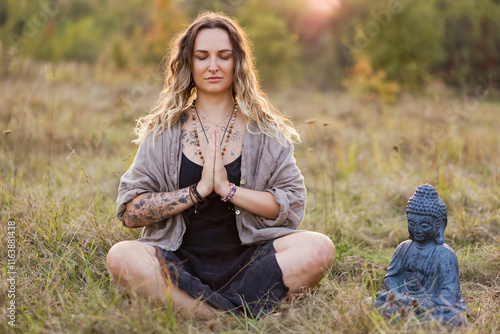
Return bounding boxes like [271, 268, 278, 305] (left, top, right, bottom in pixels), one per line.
[406, 184, 448, 245]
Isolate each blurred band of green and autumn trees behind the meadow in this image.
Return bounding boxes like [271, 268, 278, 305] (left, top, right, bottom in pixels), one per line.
[0, 0, 500, 94]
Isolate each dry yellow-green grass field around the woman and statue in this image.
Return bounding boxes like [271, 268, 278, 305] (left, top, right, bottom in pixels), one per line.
[0, 63, 500, 333]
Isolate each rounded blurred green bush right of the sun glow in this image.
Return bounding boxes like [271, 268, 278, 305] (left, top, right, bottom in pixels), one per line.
[344, 0, 444, 89]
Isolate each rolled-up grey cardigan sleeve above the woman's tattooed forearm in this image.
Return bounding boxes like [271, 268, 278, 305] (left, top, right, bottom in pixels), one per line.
[116, 135, 163, 225]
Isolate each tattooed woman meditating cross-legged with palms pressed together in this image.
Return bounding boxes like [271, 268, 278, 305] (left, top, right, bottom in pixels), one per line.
[107, 13, 335, 317]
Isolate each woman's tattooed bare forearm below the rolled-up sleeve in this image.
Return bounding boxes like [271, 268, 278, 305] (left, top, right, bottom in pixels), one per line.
[123, 188, 192, 227]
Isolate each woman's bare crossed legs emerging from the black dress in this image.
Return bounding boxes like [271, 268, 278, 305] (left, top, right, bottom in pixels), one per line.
[106, 231, 335, 318]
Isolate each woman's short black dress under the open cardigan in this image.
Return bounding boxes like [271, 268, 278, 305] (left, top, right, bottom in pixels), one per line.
[157, 155, 288, 317]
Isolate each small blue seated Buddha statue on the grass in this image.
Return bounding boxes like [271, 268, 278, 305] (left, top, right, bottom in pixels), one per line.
[375, 184, 469, 326]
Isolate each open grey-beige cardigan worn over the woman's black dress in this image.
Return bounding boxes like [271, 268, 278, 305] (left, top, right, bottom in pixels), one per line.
[116, 122, 306, 251]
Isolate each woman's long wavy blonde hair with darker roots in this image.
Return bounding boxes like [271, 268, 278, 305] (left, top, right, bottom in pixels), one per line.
[133, 12, 300, 145]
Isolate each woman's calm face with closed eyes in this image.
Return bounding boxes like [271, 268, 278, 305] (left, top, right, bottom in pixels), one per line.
[193, 28, 234, 94]
